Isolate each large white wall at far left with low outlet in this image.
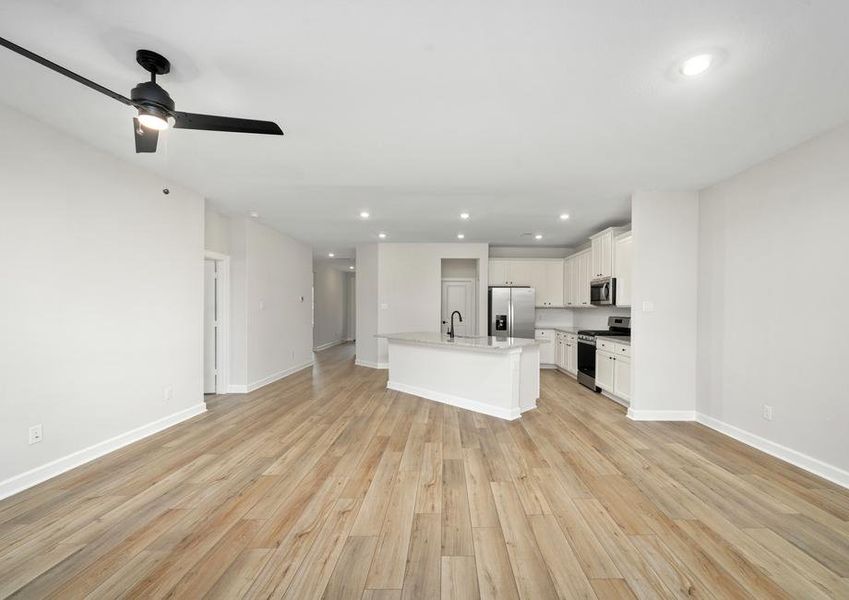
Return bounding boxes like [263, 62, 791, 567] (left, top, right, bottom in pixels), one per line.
[0, 106, 204, 495]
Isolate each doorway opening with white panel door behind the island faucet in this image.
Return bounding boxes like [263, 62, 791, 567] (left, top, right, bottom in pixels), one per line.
[441, 258, 479, 336]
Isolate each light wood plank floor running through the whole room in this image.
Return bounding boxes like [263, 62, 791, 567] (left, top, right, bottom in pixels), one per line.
[0, 345, 849, 600]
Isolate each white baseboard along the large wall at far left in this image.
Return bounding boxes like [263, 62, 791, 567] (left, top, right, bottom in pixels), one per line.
[0, 402, 206, 500]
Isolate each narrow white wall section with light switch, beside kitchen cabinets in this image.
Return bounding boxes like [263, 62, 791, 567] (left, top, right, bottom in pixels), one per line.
[629, 192, 699, 418]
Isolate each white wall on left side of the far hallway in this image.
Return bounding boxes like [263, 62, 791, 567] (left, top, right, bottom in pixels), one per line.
[313, 260, 348, 348]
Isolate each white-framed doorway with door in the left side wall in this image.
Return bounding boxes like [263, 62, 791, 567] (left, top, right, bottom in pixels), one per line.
[203, 252, 230, 394]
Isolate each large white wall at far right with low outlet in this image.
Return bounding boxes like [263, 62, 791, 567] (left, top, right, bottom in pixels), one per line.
[696, 126, 849, 478]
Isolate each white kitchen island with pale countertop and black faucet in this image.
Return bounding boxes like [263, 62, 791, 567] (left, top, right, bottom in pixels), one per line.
[376, 332, 547, 420]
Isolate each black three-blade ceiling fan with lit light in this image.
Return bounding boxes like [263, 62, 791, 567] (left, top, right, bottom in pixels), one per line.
[0, 37, 283, 152]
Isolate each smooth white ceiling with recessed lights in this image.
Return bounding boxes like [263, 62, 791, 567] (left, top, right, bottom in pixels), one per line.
[0, 0, 849, 256]
